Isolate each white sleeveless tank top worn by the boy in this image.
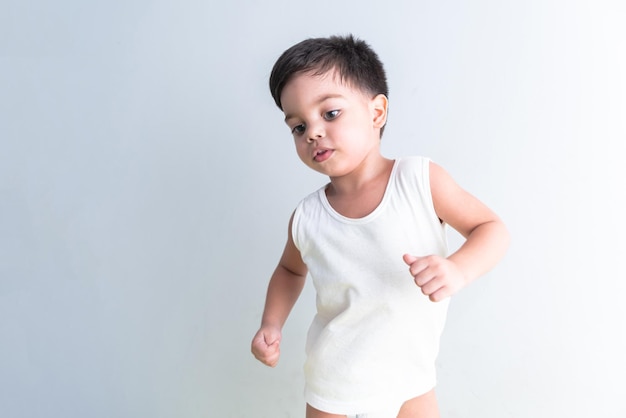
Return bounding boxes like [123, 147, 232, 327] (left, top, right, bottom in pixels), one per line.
[292, 157, 448, 414]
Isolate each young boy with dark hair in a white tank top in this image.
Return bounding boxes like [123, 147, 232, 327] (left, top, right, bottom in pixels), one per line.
[252, 36, 509, 418]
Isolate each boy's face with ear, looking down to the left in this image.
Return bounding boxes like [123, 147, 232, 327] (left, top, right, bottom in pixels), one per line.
[280, 72, 387, 179]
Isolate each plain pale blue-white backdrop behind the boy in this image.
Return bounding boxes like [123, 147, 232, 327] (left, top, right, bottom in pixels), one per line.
[0, 0, 626, 418]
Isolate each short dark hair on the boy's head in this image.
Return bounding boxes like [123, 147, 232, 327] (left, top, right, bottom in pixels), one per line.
[270, 35, 389, 110]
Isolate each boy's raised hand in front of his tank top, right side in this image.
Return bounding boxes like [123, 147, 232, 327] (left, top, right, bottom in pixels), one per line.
[402, 254, 467, 302]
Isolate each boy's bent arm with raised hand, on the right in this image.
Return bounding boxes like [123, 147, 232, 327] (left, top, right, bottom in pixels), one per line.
[404, 162, 510, 301]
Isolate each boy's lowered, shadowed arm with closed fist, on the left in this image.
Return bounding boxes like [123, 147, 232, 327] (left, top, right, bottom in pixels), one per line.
[252, 215, 307, 367]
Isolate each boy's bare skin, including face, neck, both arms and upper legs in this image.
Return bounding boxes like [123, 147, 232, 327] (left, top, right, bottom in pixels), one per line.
[252, 72, 509, 418]
